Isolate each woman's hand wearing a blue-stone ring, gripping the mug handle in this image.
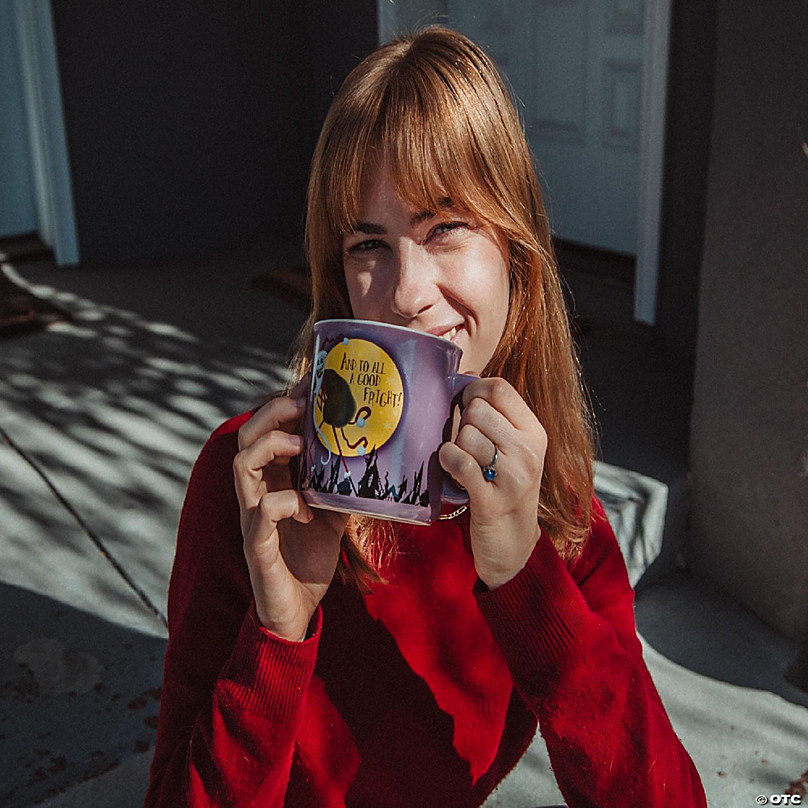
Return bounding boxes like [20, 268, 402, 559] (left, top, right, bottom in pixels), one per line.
[438, 378, 547, 589]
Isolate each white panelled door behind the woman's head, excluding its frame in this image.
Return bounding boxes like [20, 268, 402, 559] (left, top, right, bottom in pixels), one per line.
[448, 0, 644, 254]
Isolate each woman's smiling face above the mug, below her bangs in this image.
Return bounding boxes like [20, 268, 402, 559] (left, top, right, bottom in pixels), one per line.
[342, 168, 509, 373]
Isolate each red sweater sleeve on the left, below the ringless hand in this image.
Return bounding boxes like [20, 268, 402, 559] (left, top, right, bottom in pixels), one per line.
[146, 418, 322, 808]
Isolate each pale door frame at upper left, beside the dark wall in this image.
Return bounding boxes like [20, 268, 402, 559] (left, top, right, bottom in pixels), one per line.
[11, 0, 79, 266]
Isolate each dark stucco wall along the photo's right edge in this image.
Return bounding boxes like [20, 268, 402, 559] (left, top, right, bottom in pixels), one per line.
[688, 0, 808, 637]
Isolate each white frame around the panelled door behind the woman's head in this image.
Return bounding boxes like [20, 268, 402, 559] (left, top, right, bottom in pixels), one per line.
[376, 0, 671, 325]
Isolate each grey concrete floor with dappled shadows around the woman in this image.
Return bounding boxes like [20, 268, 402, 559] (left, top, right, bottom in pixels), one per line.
[0, 245, 808, 808]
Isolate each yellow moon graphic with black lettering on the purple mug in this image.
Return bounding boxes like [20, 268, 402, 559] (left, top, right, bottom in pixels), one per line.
[313, 337, 404, 457]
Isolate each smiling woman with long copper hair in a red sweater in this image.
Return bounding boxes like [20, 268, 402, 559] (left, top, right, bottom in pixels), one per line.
[147, 28, 705, 808]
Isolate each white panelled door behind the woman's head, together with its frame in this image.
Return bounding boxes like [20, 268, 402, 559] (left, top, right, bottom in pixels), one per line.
[377, 0, 672, 325]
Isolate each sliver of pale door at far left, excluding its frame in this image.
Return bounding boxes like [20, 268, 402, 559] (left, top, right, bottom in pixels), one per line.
[0, 2, 37, 238]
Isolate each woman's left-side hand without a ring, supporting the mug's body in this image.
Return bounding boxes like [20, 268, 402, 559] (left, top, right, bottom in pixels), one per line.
[233, 384, 348, 640]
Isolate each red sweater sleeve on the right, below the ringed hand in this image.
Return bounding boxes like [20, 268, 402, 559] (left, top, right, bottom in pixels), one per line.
[477, 500, 706, 808]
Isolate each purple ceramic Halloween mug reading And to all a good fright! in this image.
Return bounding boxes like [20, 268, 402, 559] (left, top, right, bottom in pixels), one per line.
[298, 320, 477, 524]
